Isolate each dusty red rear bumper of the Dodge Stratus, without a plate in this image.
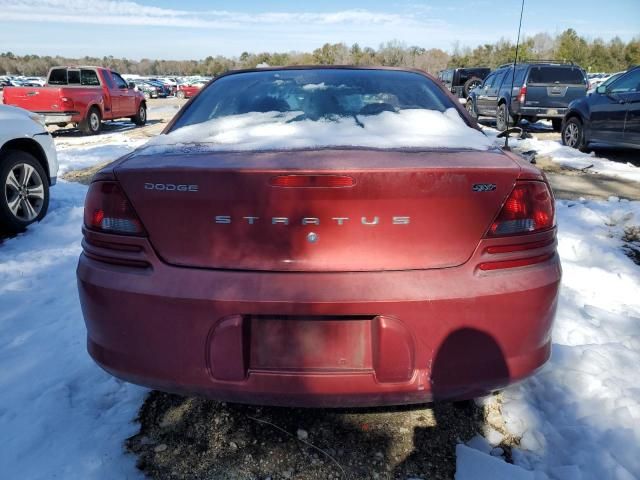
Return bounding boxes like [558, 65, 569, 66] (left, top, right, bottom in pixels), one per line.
[77, 229, 561, 407]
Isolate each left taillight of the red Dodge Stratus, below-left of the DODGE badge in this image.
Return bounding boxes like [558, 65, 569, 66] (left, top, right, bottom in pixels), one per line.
[84, 182, 146, 235]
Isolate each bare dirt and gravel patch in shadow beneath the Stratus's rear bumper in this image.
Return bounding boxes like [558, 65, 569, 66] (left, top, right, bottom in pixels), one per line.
[126, 392, 510, 480]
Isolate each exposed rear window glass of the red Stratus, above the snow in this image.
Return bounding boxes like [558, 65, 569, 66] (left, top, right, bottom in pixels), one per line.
[174, 69, 453, 130]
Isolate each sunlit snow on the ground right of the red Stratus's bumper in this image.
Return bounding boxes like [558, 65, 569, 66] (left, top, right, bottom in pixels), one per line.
[459, 197, 640, 480]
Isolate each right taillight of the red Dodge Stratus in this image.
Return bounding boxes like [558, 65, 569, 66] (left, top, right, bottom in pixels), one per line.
[488, 182, 555, 237]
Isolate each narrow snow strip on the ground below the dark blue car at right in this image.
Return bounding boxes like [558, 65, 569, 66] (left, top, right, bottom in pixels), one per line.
[484, 128, 640, 182]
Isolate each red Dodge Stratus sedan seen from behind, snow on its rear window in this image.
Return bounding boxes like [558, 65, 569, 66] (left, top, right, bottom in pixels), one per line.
[77, 67, 561, 407]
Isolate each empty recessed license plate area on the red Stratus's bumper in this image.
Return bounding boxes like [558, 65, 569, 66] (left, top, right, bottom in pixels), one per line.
[245, 315, 375, 372]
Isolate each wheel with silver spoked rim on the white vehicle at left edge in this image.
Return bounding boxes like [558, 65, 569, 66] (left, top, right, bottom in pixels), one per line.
[0, 150, 49, 234]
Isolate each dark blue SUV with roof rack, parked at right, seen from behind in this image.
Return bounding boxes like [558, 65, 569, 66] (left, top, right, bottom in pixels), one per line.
[466, 61, 587, 131]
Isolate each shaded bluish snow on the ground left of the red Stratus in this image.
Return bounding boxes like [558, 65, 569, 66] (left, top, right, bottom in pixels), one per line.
[0, 181, 145, 479]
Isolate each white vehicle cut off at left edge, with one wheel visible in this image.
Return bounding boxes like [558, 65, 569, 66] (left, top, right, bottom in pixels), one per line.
[0, 105, 58, 233]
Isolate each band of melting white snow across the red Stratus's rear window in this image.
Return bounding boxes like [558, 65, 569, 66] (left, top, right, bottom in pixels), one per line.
[144, 108, 492, 154]
